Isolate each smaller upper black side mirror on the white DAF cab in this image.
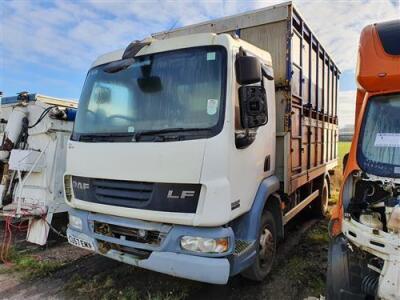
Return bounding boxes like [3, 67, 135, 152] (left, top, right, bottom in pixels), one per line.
[235, 56, 262, 85]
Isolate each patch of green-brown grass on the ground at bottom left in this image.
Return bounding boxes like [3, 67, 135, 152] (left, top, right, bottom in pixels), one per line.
[0, 248, 64, 280]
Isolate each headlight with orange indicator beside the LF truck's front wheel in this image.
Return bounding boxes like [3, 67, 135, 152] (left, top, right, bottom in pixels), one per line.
[181, 236, 229, 253]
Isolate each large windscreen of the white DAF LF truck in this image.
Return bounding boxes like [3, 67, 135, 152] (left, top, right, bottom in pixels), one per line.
[73, 46, 226, 140]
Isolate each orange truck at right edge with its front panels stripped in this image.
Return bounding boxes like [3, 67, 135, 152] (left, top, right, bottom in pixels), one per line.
[327, 20, 400, 299]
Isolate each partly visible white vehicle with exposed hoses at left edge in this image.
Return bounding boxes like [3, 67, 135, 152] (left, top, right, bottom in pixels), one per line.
[0, 93, 77, 245]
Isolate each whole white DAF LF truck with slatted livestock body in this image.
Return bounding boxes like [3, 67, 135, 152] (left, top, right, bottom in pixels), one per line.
[64, 3, 339, 284]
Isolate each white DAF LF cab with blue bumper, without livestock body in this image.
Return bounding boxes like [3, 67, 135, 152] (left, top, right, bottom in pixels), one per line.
[64, 33, 279, 283]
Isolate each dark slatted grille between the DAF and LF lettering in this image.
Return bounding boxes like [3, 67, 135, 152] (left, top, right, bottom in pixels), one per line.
[93, 179, 154, 208]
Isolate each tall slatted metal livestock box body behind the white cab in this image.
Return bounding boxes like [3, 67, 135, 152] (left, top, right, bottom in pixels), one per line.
[153, 2, 340, 195]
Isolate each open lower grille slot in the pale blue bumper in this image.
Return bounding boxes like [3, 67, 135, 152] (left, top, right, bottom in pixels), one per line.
[94, 221, 164, 246]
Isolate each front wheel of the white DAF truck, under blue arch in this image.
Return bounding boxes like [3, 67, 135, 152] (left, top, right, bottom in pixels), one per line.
[242, 211, 277, 281]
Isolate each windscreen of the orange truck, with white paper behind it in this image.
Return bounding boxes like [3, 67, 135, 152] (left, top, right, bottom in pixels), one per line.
[357, 94, 400, 178]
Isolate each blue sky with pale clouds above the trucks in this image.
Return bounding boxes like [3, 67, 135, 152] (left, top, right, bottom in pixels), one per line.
[0, 0, 400, 126]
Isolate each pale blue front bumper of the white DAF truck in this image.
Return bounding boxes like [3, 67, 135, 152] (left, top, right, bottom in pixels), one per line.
[67, 209, 244, 284]
